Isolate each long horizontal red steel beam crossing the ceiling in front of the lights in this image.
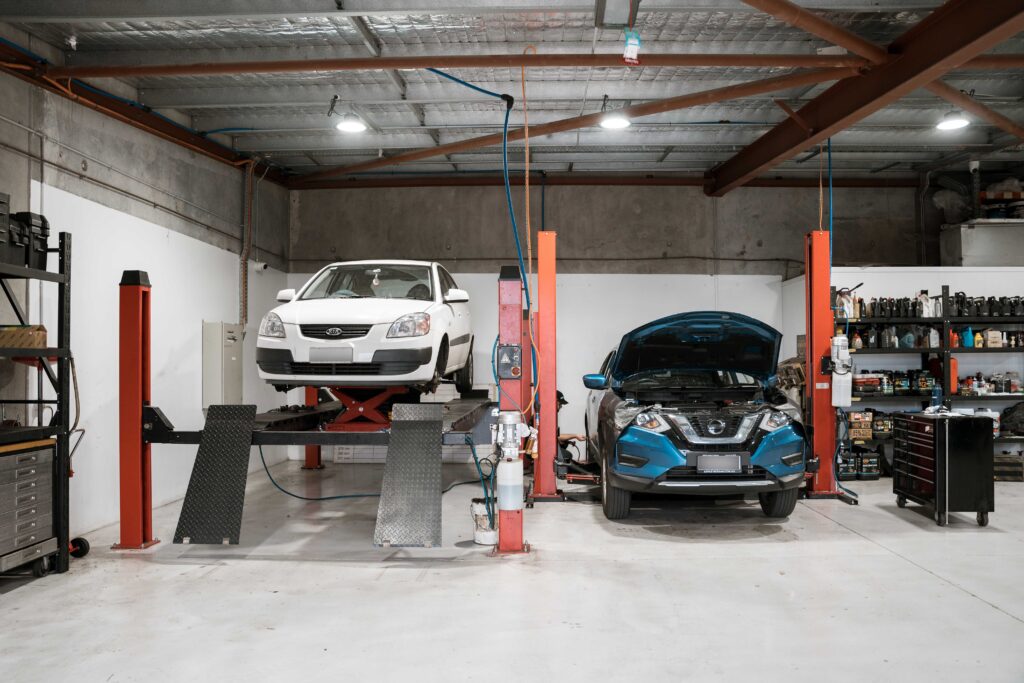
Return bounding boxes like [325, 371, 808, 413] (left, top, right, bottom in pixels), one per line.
[43, 52, 1024, 79]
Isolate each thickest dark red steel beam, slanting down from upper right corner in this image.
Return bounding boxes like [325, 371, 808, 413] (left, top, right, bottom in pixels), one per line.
[705, 0, 1024, 197]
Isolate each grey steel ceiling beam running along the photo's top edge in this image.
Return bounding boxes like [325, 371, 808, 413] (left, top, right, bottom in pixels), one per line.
[0, 0, 941, 24]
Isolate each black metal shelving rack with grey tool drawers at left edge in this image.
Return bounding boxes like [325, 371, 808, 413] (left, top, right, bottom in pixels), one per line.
[0, 232, 74, 575]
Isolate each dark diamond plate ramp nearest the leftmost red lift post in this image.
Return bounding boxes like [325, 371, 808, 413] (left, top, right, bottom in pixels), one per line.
[174, 405, 256, 545]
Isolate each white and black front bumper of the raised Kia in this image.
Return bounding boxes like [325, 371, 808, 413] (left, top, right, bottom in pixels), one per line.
[256, 324, 436, 386]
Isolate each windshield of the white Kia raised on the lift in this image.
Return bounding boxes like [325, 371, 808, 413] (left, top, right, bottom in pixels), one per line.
[301, 263, 434, 301]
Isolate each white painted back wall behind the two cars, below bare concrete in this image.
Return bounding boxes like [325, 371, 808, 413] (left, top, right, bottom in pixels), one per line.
[288, 272, 782, 432]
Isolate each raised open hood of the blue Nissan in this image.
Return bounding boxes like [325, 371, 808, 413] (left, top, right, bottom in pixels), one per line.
[611, 311, 782, 383]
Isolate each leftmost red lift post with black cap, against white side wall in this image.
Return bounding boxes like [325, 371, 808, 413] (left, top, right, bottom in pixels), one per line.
[114, 270, 160, 550]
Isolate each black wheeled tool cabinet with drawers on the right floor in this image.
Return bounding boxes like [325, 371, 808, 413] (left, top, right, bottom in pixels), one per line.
[893, 414, 995, 526]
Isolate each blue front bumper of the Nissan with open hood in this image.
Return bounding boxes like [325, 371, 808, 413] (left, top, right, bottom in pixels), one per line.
[606, 427, 806, 496]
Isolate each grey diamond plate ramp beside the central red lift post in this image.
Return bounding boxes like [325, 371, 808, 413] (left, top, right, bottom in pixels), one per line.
[374, 403, 443, 547]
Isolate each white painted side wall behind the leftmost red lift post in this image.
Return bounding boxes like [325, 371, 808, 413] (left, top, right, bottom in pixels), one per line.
[32, 182, 286, 533]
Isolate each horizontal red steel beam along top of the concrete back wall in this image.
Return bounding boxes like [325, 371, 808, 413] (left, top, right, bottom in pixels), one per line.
[294, 173, 921, 189]
